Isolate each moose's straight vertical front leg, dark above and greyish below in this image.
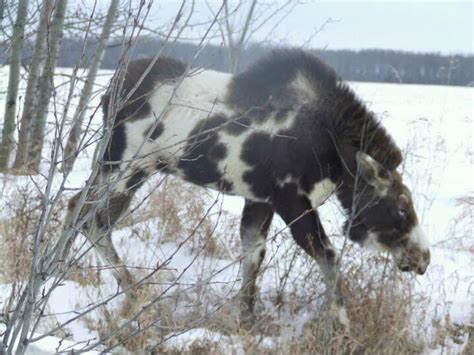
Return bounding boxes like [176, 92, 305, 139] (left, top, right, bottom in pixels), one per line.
[240, 200, 273, 323]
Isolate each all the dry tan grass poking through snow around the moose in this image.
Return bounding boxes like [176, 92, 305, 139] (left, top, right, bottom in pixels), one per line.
[0, 179, 468, 354]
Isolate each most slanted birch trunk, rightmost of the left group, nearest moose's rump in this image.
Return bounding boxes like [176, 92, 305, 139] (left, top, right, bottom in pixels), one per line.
[63, 0, 119, 171]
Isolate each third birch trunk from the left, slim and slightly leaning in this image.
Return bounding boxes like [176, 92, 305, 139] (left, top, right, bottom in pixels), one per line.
[27, 0, 67, 171]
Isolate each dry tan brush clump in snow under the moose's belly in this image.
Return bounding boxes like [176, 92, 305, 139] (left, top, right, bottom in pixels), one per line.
[127, 176, 239, 258]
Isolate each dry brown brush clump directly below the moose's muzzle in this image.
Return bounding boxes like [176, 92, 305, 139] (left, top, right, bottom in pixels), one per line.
[344, 256, 427, 354]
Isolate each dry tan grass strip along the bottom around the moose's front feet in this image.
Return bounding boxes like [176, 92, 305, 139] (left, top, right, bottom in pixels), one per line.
[82, 246, 429, 354]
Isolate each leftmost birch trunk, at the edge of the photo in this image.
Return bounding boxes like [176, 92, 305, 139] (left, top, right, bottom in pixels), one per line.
[0, 0, 28, 171]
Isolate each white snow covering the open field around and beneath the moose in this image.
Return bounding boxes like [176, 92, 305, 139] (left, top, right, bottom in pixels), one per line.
[0, 68, 474, 353]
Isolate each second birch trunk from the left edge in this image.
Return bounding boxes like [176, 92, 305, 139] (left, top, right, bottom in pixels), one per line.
[13, 0, 54, 173]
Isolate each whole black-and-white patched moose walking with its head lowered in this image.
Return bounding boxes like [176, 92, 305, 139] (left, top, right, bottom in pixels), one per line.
[68, 49, 430, 326]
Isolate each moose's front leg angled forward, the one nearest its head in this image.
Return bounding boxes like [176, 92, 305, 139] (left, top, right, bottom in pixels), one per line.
[274, 185, 349, 332]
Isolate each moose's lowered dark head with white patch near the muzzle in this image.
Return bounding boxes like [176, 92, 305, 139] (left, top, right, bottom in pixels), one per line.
[344, 151, 430, 275]
